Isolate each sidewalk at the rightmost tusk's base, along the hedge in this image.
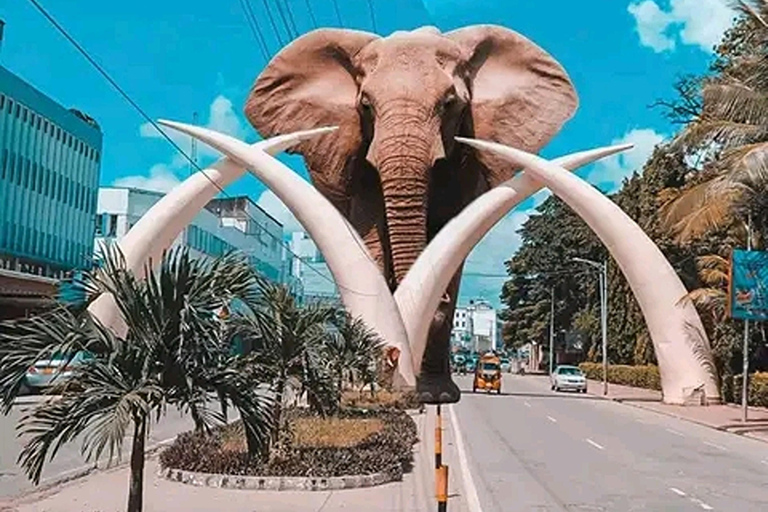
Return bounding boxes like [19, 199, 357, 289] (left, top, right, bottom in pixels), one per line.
[588, 380, 768, 442]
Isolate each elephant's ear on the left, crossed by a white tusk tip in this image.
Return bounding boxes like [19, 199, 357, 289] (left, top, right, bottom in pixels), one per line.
[245, 29, 379, 207]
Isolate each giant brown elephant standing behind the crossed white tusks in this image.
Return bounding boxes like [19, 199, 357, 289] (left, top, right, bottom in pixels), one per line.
[244, 25, 579, 404]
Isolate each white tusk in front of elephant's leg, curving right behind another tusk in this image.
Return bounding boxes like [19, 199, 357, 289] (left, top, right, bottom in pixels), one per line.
[395, 144, 633, 368]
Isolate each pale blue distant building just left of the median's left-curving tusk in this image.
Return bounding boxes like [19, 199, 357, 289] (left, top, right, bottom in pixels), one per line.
[289, 231, 339, 301]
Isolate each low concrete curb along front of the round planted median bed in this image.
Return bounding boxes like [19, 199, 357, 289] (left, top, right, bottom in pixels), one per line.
[158, 468, 399, 491]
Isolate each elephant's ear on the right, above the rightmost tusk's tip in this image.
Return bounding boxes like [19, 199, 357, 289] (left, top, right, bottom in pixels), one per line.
[445, 25, 579, 187]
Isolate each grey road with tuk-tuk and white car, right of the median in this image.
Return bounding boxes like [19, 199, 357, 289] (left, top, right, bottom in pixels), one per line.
[453, 375, 768, 512]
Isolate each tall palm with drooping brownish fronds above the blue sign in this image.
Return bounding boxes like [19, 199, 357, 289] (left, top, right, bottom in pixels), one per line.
[663, 0, 768, 243]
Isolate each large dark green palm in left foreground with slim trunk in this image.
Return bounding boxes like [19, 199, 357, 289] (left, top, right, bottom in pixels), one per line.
[0, 247, 271, 512]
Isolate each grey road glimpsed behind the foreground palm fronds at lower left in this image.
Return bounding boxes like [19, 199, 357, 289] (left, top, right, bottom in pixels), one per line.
[0, 396, 230, 498]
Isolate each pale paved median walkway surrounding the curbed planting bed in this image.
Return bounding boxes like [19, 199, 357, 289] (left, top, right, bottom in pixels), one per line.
[0, 407, 467, 512]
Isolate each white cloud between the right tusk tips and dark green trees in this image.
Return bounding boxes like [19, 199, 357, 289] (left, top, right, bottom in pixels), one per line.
[586, 128, 666, 192]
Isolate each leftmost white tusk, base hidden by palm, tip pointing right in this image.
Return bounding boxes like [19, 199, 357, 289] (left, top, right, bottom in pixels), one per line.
[88, 128, 333, 336]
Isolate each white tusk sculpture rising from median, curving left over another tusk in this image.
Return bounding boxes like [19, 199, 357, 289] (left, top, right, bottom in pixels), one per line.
[159, 121, 416, 386]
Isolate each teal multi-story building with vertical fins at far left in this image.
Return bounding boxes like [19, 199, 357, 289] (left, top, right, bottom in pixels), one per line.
[0, 58, 102, 317]
